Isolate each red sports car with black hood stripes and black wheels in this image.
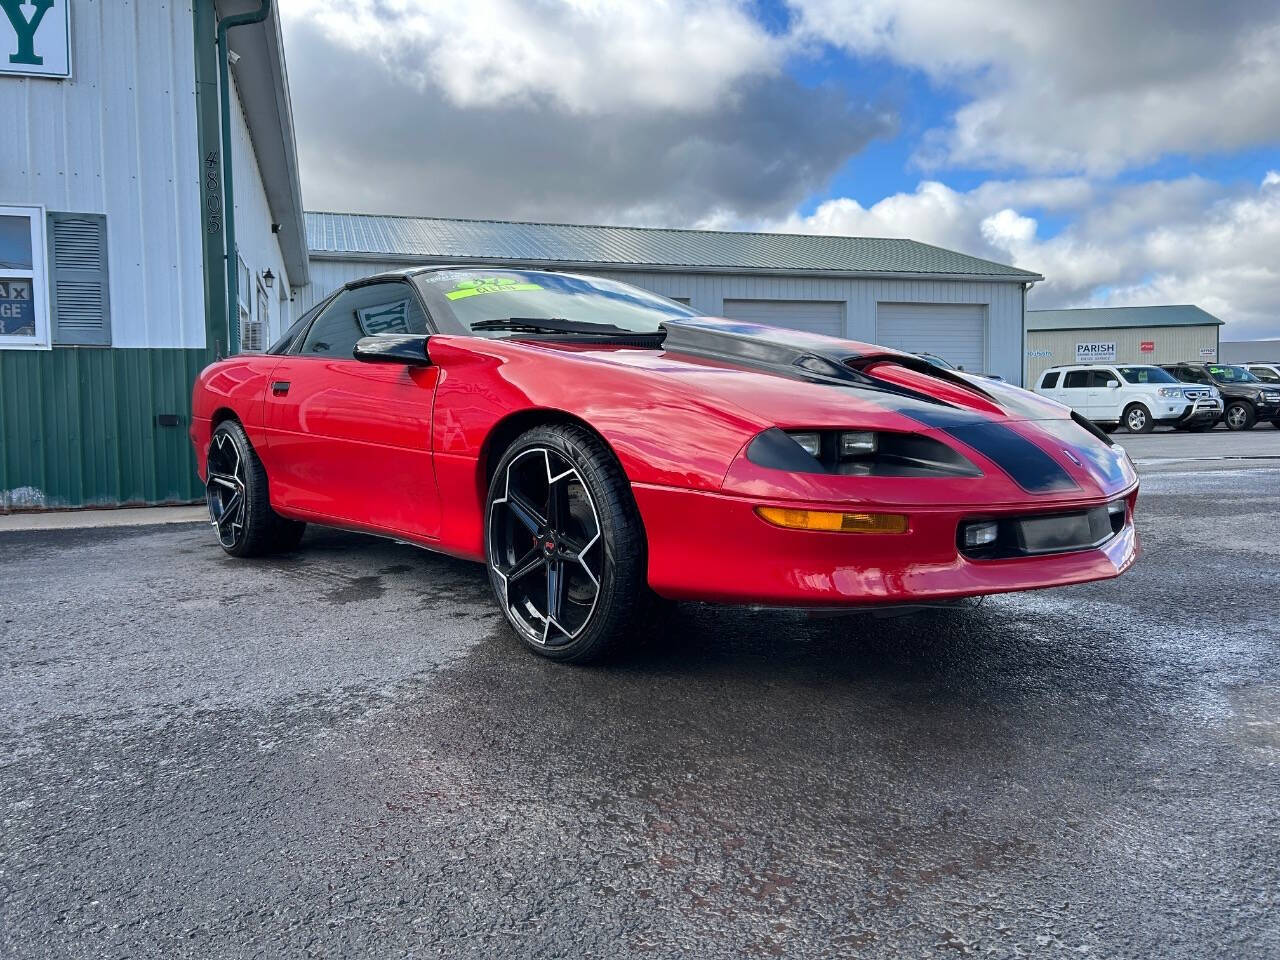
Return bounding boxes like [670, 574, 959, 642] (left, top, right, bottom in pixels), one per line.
[191, 268, 1138, 660]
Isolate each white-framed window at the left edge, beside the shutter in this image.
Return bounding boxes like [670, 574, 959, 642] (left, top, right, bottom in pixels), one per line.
[0, 206, 49, 349]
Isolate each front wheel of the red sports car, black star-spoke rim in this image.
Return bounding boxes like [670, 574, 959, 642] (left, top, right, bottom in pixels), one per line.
[485, 424, 649, 663]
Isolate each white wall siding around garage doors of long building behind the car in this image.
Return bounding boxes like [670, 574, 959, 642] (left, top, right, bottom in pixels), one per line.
[294, 257, 1023, 384]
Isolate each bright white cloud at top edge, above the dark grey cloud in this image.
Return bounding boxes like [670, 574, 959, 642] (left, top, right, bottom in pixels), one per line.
[284, 0, 788, 114]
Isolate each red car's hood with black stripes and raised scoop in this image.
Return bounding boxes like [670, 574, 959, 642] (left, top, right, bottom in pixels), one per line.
[514, 317, 1137, 498]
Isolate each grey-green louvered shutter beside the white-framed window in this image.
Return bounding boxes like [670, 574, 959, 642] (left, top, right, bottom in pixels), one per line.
[49, 214, 111, 347]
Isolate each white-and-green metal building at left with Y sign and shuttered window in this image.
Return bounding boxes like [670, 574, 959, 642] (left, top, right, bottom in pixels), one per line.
[0, 0, 307, 511]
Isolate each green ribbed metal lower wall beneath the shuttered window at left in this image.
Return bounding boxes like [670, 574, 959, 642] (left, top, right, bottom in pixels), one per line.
[0, 347, 212, 512]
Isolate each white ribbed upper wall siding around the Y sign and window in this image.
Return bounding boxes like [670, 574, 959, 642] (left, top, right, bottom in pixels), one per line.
[0, 0, 205, 347]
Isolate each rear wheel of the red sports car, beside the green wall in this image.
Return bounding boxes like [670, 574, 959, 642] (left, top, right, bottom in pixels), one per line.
[205, 420, 307, 557]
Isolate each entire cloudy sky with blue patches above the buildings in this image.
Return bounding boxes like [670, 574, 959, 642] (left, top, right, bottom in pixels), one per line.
[282, 0, 1280, 339]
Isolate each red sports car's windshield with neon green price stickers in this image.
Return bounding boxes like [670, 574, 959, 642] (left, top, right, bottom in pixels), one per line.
[413, 270, 698, 337]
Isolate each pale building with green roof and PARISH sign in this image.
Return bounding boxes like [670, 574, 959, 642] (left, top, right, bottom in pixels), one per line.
[1027, 303, 1222, 383]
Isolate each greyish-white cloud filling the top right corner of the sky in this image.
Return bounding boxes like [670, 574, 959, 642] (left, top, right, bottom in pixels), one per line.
[790, 0, 1280, 175]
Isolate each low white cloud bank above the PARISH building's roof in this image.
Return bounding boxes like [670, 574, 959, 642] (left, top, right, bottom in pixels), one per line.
[769, 173, 1280, 339]
